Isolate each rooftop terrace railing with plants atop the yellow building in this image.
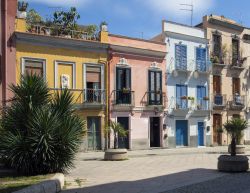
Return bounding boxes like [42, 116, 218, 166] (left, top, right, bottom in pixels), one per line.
[27, 24, 98, 41]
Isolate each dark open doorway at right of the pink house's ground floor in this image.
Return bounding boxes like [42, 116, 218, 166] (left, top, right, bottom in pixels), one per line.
[150, 117, 161, 147]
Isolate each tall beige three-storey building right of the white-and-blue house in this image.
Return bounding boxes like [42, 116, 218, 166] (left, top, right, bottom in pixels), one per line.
[198, 15, 249, 145]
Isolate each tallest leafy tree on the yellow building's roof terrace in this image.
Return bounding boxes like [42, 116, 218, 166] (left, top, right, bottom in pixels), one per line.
[53, 7, 80, 35]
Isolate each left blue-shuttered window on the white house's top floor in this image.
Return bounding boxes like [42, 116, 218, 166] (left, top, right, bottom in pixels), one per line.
[175, 44, 187, 70]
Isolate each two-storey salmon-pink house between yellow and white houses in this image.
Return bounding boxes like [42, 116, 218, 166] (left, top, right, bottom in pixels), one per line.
[108, 34, 167, 149]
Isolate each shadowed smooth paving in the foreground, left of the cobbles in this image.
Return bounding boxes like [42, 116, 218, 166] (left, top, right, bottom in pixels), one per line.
[62, 168, 227, 193]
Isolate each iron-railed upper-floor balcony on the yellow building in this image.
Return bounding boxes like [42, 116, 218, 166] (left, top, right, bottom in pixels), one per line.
[50, 88, 105, 109]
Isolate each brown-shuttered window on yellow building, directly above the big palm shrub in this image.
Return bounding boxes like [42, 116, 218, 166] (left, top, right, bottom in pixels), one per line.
[22, 58, 45, 77]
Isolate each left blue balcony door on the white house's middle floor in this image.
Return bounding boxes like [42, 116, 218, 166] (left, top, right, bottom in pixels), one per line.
[176, 84, 188, 109]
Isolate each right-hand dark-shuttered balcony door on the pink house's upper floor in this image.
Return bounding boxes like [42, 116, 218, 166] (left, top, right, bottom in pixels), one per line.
[148, 70, 162, 105]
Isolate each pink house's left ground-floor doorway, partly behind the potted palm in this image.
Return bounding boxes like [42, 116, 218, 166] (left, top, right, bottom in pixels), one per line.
[117, 117, 129, 149]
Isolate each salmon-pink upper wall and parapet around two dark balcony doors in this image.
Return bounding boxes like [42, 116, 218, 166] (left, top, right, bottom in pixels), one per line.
[109, 36, 166, 106]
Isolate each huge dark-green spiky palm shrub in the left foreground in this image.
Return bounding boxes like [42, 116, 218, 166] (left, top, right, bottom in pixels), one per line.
[0, 75, 85, 175]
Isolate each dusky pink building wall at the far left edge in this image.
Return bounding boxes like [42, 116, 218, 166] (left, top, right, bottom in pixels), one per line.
[0, 0, 17, 105]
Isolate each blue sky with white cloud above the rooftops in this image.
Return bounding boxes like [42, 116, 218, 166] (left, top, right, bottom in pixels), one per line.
[26, 0, 250, 39]
